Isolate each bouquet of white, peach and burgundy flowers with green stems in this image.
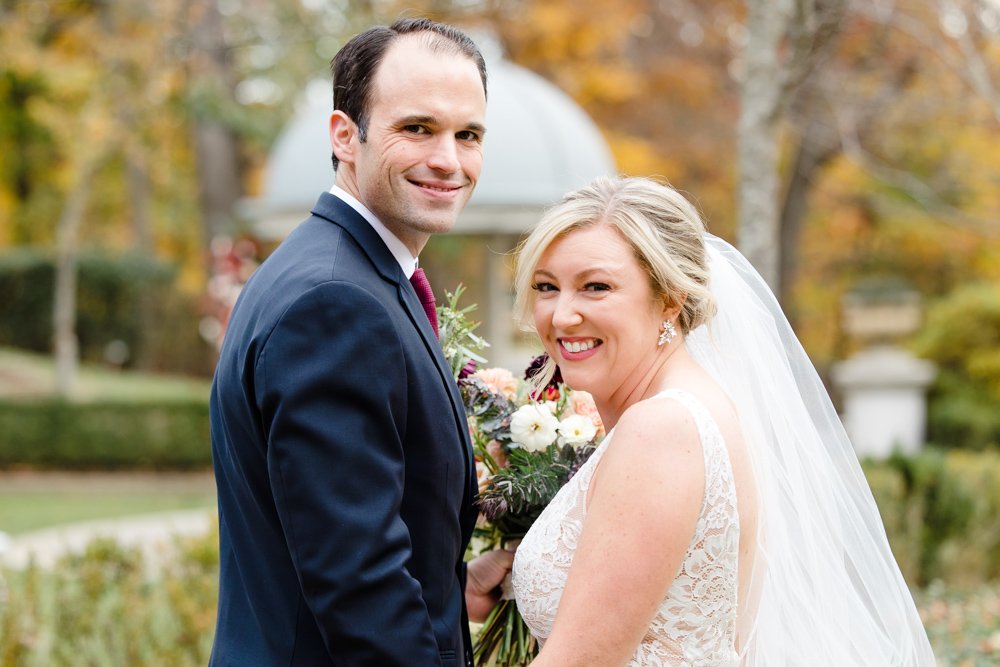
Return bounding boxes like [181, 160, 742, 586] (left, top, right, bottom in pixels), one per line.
[438, 287, 604, 667]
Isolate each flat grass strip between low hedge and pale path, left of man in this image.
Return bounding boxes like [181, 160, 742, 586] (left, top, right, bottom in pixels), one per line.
[0, 472, 215, 535]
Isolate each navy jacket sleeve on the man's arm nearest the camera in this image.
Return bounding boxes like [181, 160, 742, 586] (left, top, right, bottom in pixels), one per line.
[256, 282, 439, 666]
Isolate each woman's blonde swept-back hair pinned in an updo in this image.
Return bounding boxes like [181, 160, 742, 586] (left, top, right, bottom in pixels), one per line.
[514, 176, 715, 386]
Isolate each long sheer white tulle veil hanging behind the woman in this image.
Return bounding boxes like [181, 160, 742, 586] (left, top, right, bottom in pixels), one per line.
[687, 235, 934, 667]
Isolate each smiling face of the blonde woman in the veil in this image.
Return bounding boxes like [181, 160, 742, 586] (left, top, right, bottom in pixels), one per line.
[532, 225, 665, 407]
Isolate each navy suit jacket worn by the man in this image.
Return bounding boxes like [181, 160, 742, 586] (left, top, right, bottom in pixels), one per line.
[210, 193, 476, 667]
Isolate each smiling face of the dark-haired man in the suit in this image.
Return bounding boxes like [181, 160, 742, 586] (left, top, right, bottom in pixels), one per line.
[338, 35, 486, 254]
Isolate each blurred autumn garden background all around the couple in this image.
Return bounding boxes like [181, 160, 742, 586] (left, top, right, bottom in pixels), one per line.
[0, 0, 1000, 665]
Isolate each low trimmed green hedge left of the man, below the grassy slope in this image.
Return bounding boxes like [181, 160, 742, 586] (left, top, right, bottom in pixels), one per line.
[0, 400, 212, 470]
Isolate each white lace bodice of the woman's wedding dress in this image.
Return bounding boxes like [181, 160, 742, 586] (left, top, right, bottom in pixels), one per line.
[513, 390, 739, 667]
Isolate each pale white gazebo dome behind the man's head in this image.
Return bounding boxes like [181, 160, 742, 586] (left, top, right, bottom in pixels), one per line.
[244, 43, 616, 239]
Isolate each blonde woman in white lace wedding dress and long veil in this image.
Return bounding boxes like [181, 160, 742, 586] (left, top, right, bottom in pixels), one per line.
[513, 178, 934, 667]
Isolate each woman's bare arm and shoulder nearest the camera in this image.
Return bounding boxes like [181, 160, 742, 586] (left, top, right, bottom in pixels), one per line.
[532, 400, 705, 667]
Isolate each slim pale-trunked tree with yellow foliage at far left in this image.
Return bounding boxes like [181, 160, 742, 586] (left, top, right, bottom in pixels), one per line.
[3, 3, 182, 395]
